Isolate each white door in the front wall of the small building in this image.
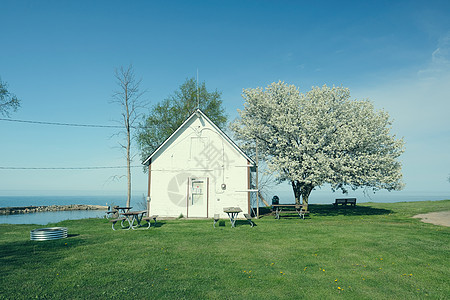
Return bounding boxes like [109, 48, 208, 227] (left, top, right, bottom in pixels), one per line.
[188, 178, 208, 218]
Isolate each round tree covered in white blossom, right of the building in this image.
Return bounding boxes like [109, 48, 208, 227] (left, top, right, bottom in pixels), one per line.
[231, 82, 404, 209]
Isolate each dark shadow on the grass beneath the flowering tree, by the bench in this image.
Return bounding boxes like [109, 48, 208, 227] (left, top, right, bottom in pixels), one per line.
[308, 204, 393, 216]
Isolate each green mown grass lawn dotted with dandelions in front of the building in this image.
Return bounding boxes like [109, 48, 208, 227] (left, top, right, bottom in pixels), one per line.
[0, 200, 450, 299]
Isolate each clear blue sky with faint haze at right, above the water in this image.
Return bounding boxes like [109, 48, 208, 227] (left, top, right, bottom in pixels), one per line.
[0, 1, 450, 197]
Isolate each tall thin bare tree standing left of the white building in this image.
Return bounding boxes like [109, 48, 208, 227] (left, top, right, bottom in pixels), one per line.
[111, 65, 145, 206]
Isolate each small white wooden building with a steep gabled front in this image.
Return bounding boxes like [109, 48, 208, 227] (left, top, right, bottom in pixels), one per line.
[143, 109, 255, 218]
